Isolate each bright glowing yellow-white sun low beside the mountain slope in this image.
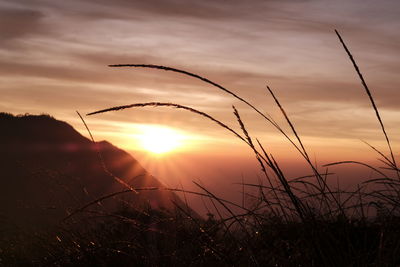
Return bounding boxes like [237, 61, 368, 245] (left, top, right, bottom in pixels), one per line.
[137, 126, 184, 155]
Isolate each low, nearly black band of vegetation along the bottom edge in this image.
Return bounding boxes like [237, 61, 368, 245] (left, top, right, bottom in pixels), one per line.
[2, 204, 400, 266]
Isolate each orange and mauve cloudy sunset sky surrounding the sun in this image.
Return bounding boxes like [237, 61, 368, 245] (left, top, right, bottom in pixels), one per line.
[0, 0, 400, 207]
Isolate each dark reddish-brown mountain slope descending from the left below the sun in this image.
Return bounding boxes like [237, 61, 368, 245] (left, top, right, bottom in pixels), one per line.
[0, 113, 183, 232]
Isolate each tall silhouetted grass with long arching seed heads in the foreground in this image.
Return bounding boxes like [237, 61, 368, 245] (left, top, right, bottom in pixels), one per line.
[3, 31, 400, 266]
